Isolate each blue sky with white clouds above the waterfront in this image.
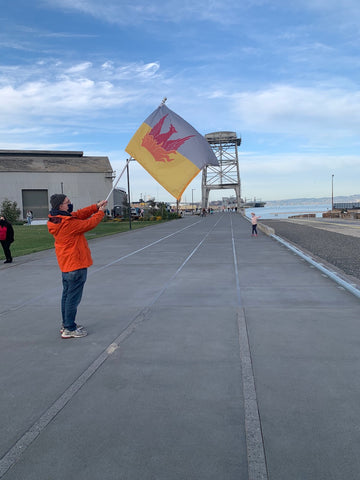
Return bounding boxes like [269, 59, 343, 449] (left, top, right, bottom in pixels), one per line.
[0, 0, 360, 202]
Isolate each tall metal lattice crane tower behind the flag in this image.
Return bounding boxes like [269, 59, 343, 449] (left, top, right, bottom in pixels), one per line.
[202, 132, 241, 210]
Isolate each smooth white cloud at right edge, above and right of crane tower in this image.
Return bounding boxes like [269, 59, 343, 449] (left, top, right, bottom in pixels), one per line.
[231, 85, 360, 138]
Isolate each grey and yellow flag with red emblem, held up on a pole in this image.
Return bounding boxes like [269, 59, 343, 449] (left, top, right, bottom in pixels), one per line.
[125, 103, 219, 200]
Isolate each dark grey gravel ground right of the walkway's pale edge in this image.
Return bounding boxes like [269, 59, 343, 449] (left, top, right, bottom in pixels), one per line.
[261, 220, 360, 279]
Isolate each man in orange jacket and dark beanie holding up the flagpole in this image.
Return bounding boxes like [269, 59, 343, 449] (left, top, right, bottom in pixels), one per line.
[47, 193, 107, 338]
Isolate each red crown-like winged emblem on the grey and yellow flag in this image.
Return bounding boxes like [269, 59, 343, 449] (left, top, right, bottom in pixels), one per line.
[141, 115, 195, 162]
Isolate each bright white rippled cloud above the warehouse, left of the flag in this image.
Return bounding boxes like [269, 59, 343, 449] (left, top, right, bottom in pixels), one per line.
[0, 61, 159, 127]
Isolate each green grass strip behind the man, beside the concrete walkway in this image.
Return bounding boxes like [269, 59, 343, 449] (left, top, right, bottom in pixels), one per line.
[0, 221, 175, 260]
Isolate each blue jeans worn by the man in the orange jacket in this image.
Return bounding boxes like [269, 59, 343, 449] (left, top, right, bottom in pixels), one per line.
[61, 268, 87, 330]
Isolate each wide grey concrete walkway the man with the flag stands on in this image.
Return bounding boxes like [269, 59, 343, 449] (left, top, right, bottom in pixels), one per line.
[0, 214, 360, 480]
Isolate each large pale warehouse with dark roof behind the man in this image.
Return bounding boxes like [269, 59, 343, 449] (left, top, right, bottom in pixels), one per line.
[0, 150, 114, 219]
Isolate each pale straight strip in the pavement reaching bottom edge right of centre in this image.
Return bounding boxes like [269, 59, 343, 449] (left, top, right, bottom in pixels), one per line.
[231, 220, 268, 480]
